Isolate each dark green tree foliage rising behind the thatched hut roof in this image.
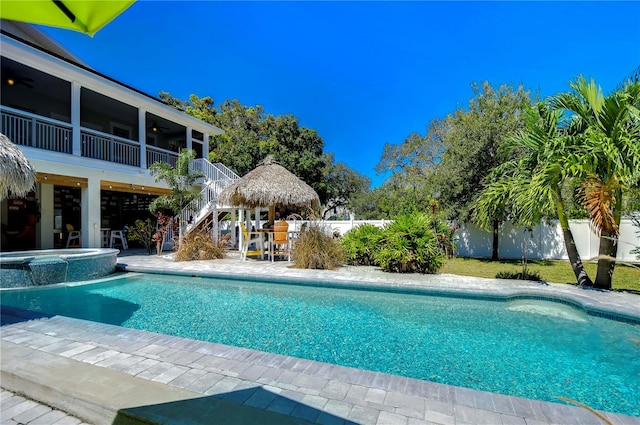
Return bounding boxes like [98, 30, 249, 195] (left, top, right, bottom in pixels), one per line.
[160, 92, 370, 208]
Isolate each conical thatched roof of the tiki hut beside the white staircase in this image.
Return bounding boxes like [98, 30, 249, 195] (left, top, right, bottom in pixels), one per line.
[218, 155, 320, 208]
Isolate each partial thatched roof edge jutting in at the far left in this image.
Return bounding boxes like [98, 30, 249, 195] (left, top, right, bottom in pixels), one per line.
[0, 133, 36, 200]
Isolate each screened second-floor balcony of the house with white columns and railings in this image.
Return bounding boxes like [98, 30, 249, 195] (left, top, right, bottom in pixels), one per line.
[0, 47, 221, 169]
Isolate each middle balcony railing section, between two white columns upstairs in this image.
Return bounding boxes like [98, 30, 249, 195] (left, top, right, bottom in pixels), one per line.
[80, 129, 140, 167]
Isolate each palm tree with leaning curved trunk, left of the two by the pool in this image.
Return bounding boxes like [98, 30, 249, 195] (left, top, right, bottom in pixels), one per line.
[473, 102, 592, 286]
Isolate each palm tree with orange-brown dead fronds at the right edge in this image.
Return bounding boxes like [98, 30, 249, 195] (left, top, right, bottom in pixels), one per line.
[551, 75, 640, 289]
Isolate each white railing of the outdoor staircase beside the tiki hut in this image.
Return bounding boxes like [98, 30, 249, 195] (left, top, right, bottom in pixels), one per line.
[182, 158, 240, 232]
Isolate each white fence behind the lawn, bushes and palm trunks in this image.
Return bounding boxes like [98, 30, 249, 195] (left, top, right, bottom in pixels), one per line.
[316, 220, 640, 262]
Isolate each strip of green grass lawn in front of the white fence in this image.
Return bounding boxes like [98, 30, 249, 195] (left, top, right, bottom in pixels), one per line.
[440, 258, 640, 293]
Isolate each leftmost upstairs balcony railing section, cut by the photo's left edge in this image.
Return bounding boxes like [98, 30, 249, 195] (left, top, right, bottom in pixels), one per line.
[0, 106, 72, 154]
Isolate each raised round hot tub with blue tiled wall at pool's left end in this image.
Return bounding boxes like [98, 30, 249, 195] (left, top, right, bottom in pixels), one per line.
[0, 248, 120, 288]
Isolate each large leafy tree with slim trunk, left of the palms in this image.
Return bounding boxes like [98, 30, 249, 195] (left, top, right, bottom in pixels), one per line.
[376, 81, 530, 259]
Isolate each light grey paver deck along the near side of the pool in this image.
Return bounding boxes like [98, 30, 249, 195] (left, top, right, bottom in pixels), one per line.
[2, 309, 640, 425]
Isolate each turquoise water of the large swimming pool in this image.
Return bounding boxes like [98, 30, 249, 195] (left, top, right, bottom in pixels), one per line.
[2, 275, 640, 416]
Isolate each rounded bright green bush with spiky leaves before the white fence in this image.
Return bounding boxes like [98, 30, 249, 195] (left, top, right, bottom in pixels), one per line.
[375, 213, 443, 273]
